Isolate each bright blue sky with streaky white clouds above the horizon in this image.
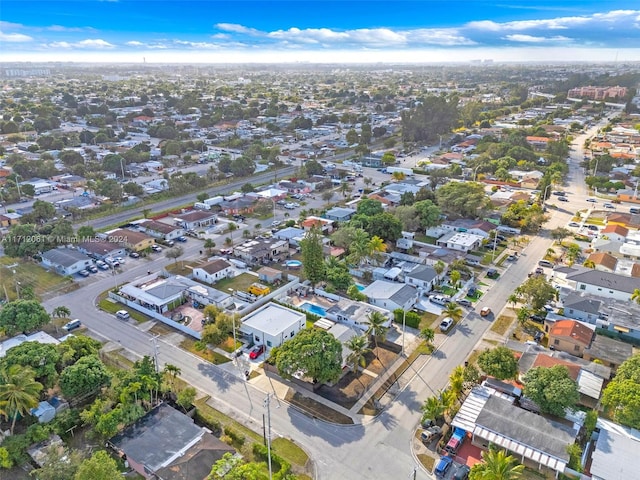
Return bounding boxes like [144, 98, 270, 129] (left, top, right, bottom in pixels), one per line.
[0, 0, 640, 63]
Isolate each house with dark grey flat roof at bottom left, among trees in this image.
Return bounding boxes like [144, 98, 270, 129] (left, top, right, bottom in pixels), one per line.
[107, 403, 235, 480]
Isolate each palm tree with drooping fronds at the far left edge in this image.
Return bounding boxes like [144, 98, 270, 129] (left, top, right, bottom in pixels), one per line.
[0, 365, 43, 435]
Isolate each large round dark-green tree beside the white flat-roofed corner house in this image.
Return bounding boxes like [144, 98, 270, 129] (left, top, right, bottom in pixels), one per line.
[271, 328, 342, 383]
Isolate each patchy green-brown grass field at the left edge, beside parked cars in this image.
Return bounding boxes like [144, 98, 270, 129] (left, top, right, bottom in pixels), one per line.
[0, 257, 79, 301]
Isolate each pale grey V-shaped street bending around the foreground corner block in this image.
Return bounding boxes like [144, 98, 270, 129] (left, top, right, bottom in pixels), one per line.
[45, 115, 620, 480]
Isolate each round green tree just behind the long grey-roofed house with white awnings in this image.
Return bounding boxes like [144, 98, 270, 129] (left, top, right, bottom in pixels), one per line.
[524, 365, 580, 417]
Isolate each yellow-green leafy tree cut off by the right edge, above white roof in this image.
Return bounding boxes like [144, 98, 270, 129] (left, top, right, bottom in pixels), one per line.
[602, 355, 640, 428]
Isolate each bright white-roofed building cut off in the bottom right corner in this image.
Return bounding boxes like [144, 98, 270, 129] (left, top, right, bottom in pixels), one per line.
[589, 418, 640, 480]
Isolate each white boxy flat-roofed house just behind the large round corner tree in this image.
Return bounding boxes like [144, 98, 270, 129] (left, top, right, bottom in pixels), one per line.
[240, 303, 307, 351]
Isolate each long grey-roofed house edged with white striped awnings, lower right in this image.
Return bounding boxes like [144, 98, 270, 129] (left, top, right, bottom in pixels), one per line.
[451, 386, 578, 474]
